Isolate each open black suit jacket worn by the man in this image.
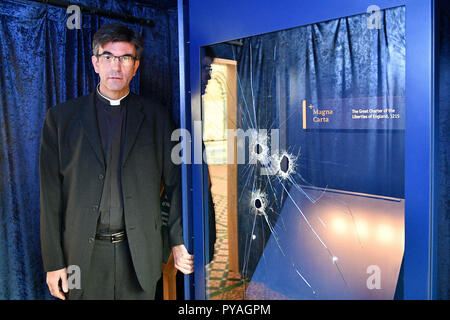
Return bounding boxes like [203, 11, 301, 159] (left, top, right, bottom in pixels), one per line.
[39, 93, 183, 292]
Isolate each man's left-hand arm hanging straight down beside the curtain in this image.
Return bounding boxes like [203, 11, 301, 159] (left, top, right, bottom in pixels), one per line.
[39, 108, 67, 299]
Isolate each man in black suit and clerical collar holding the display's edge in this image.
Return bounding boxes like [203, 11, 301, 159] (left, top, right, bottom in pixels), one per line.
[39, 24, 193, 299]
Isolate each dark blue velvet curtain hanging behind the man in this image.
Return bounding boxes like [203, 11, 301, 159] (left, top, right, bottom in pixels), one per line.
[0, 0, 179, 299]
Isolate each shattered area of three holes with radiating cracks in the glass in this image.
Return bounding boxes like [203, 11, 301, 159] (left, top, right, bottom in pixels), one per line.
[204, 43, 361, 295]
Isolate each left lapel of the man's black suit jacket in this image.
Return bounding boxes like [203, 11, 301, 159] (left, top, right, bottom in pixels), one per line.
[80, 93, 105, 168]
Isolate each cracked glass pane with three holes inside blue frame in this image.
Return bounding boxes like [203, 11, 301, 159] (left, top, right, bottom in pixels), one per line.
[202, 7, 406, 299]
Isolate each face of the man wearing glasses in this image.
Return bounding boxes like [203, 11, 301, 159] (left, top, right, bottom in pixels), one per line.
[92, 42, 139, 99]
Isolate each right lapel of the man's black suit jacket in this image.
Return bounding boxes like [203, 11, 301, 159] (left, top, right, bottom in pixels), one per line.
[122, 92, 144, 165]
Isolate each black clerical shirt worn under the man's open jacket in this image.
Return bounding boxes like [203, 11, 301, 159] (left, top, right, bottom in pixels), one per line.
[95, 89, 128, 233]
